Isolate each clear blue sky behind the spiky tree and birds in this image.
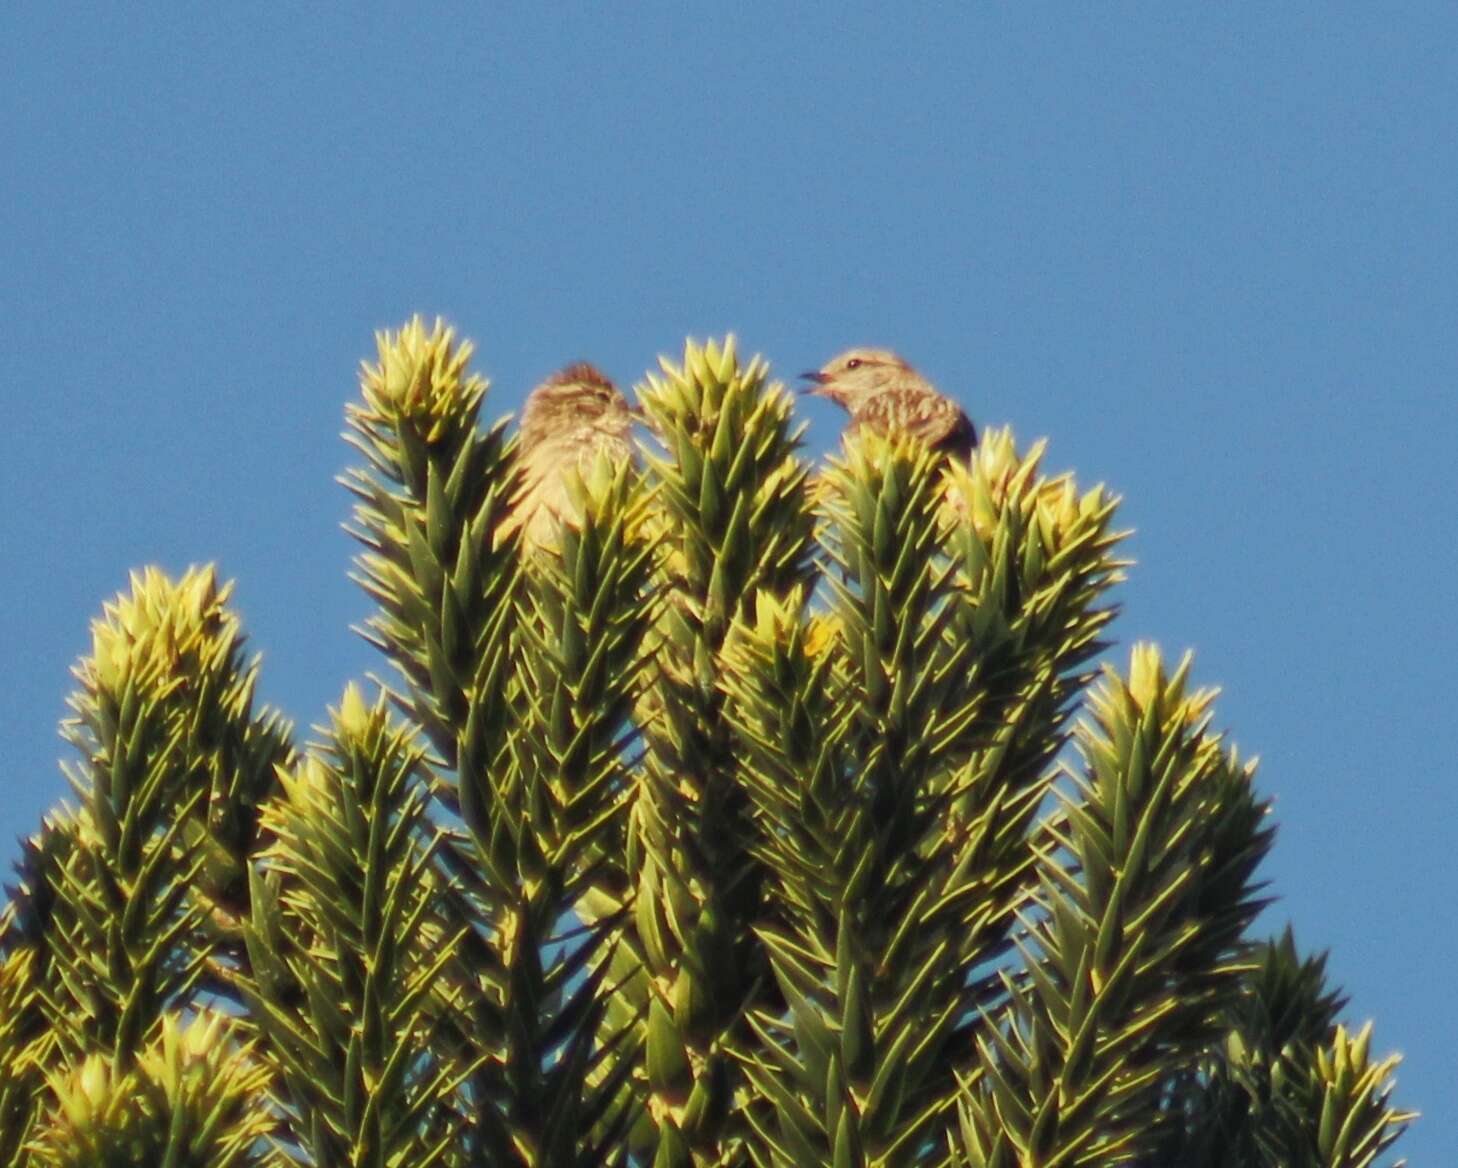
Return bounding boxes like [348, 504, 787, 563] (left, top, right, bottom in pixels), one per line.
[0, 9, 1458, 1164]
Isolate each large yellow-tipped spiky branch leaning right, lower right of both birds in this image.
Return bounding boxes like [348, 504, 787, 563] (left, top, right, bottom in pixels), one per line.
[962, 646, 1271, 1165]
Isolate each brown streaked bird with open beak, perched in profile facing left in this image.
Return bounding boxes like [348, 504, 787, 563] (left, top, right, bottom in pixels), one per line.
[800, 349, 977, 462]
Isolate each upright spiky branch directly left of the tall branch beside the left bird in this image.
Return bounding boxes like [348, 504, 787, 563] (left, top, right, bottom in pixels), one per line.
[245, 685, 469, 1168]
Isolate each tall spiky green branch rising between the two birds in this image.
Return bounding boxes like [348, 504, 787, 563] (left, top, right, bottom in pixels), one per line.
[612, 340, 812, 1168]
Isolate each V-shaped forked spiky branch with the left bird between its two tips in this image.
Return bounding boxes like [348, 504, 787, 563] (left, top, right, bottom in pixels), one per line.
[346, 321, 653, 1165]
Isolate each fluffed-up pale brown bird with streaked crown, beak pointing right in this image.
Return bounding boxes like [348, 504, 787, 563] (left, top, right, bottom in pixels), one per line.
[500, 362, 633, 547]
